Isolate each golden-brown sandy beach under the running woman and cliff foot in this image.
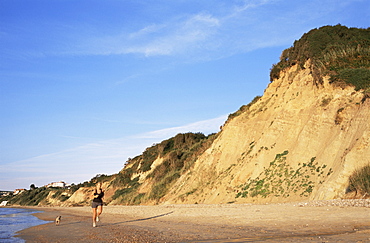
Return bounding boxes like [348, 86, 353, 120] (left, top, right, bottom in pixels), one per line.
[17, 200, 370, 242]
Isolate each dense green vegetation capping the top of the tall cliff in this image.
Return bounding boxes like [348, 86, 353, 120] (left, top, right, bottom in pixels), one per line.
[270, 25, 370, 93]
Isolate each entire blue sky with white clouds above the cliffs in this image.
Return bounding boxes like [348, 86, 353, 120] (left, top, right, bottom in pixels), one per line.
[0, 0, 370, 190]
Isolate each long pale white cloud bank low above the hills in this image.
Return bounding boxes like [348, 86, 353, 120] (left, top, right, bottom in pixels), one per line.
[0, 116, 226, 190]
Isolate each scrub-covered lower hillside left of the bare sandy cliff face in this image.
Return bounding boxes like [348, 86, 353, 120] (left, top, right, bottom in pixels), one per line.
[111, 133, 216, 205]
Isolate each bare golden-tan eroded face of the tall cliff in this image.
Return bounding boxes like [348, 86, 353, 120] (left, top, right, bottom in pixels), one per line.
[162, 61, 370, 203]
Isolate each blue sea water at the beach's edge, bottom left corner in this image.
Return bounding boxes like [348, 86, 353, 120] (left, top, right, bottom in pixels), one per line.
[0, 207, 50, 243]
